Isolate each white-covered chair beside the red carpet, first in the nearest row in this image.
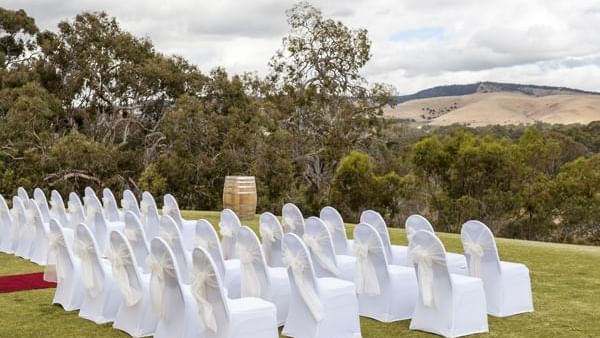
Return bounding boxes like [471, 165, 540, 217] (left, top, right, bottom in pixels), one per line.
[44, 219, 85, 311]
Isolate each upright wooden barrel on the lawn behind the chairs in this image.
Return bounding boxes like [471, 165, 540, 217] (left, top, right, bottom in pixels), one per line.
[223, 176, 256, 219]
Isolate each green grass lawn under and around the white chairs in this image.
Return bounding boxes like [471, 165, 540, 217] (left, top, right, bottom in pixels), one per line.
[0, 211, 600, 338]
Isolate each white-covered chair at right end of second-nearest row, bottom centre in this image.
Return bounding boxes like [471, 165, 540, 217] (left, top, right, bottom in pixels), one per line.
[282, 233, 361, 338]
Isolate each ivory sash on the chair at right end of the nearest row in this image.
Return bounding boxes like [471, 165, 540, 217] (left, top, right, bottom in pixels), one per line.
[191, 270, 218, 333]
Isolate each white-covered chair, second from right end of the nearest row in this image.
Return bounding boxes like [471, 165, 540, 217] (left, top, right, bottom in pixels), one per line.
[148, 237, 201, 338]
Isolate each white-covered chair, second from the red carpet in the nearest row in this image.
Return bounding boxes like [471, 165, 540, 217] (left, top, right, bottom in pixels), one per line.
[73, 224, 123, 324]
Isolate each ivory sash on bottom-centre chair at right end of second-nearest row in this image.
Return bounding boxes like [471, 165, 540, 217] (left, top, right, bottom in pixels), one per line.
[282, 249, 323, 322]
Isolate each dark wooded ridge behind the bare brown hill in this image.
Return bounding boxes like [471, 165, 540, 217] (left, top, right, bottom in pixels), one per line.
[397, 82, 600, 103]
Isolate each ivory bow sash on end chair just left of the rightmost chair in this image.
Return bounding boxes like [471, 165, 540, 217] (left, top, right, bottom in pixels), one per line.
[409, 245, 446, 307]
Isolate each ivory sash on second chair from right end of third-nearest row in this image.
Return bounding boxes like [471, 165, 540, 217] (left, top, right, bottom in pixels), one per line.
[354, 238, 381, 296]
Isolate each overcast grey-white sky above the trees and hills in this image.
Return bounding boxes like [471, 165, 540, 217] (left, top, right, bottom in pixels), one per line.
[0, 0, 600, 94]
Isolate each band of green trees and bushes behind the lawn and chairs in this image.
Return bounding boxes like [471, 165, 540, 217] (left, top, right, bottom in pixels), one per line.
[0, 2, 600, 244]
